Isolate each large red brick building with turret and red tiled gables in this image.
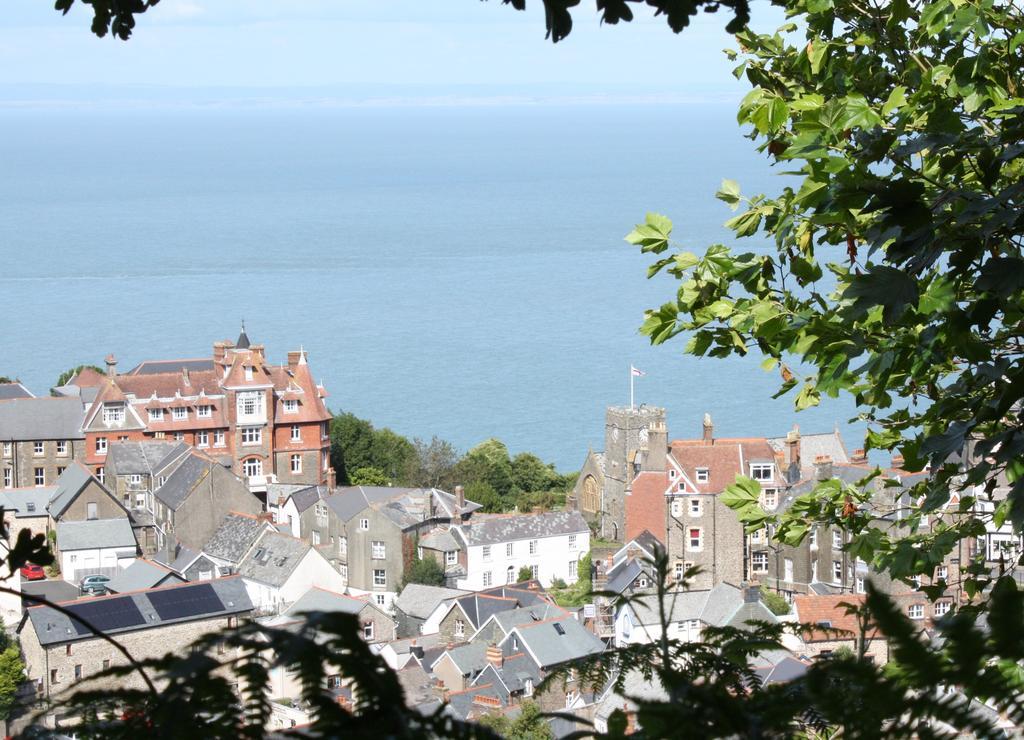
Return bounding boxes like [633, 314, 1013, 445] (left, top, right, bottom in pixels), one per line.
[72, 328, 334, 487]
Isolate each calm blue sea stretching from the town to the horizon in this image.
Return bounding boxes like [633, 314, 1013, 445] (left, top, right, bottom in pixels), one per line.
[0, 102, 863, 470]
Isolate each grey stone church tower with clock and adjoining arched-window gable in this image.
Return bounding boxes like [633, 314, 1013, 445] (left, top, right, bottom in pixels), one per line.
[568, 405, 668, 541]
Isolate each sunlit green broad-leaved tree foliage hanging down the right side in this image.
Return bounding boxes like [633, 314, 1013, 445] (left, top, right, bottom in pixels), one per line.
[627, 0, 1024, 594]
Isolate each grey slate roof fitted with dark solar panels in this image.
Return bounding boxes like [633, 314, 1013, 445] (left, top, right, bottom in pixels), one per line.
[22, 577, 253, 646]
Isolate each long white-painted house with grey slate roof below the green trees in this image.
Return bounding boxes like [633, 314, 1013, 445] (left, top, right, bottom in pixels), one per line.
[452, 512, 590, 591]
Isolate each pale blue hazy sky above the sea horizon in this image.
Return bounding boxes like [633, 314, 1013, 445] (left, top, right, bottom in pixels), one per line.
[0, 0, 781, 104]
